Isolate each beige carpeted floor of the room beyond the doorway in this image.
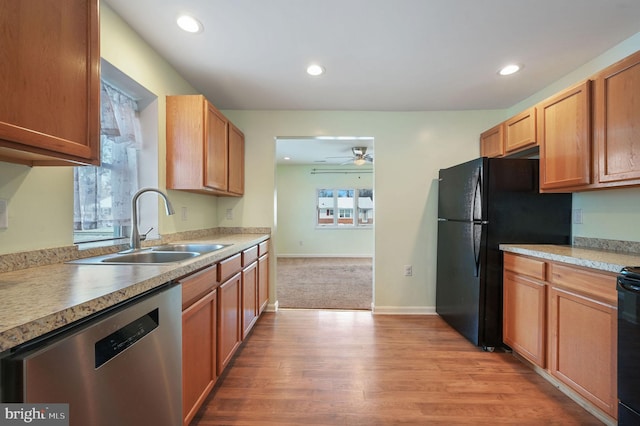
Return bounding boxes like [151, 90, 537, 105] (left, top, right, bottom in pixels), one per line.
[277, 257, 373, 310]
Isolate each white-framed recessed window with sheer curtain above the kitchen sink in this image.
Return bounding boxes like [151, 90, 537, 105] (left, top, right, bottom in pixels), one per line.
[73, 59, 158, 247]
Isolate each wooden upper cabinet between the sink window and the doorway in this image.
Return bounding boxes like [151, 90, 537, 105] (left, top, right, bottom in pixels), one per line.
[167, 95, 244, 196]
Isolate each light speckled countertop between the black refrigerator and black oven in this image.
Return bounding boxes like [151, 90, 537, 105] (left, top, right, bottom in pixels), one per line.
[500, 244, 640, 273]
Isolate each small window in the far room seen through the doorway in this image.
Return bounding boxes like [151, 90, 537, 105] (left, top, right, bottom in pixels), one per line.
[316, 188, 373, 228]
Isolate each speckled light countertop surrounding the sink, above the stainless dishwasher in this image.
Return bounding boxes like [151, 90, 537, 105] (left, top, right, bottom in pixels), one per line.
[0, 234, 269, 353]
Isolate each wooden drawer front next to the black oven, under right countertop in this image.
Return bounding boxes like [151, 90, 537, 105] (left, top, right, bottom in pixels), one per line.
[549, 263, 618, 306]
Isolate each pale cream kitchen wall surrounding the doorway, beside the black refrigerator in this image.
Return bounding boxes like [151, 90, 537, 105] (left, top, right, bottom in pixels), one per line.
[218, 111, 502, 312]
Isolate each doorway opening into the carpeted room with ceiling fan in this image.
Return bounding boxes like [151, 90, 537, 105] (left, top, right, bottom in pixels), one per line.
[275, 137, 375, 310]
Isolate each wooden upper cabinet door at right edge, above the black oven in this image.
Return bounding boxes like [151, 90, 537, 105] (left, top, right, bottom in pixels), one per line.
[594, 52, 640, 186]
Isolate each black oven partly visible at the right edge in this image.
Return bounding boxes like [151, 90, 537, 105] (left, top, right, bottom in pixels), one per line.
[617, 267, 640, 425]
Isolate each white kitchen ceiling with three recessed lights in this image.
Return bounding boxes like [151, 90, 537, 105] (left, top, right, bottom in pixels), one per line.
[103, 0, 640, 163]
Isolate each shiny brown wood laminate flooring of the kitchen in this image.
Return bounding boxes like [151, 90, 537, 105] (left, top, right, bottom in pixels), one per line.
[192, 310, 602, 426]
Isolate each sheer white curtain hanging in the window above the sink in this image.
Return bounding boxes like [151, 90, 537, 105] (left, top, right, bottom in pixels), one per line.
[73, 81, 142, 236]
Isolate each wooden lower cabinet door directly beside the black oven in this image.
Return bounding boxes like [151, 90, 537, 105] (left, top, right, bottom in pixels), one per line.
[549, 287, 618, 417]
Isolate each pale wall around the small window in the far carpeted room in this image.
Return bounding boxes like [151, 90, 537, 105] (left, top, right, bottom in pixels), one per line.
[275, 165, 375, 257]
